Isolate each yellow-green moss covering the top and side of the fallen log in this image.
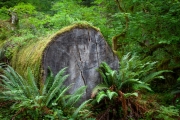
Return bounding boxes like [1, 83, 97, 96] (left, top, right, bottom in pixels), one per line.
[11, 23, 99, 82]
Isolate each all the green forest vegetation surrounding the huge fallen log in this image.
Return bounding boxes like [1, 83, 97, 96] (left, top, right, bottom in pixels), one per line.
[0, 0, 180, 120]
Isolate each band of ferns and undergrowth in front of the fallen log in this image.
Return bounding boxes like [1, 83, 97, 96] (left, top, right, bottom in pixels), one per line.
[0, 53, 180, 120]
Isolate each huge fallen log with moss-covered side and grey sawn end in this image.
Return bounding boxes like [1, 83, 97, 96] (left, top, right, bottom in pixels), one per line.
[12, 24, 119, 99]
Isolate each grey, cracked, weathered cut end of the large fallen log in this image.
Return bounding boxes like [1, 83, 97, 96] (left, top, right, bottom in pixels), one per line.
[41, 27, 119, 100]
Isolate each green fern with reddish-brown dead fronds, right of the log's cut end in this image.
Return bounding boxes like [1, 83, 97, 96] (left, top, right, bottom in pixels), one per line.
[91, 53, 169, 119]
